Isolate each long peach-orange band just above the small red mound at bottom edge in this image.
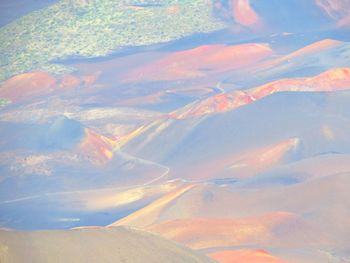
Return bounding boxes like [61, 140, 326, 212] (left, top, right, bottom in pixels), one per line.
[147, 212, 315, 252]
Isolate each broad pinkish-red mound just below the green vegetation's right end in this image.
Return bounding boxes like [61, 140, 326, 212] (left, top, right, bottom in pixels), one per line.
[124, 44, 273, 82]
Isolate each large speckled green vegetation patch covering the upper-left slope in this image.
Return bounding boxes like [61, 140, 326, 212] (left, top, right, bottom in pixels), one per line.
[0, 0, 224, 81]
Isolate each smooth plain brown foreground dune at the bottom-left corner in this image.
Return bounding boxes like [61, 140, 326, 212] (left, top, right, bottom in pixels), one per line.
[0, 227, 212, 263]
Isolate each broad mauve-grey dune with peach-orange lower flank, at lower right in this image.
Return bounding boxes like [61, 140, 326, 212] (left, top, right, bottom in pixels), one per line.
[116, 174, 349, 255]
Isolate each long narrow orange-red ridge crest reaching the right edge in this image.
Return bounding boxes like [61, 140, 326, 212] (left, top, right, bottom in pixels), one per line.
[171, 68, 350, 119]
